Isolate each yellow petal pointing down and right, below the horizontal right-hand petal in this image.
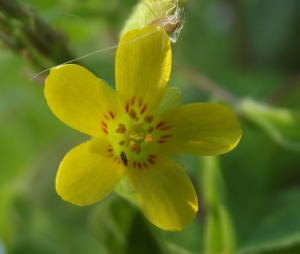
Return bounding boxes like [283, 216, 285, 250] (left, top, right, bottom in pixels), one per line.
[128, 156, 198, 231]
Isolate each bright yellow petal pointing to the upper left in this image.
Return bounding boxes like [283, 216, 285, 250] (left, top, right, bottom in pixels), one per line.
[45, 64, 118, 137]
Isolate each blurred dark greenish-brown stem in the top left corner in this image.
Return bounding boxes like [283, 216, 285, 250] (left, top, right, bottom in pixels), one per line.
[0, 0, 75, 69]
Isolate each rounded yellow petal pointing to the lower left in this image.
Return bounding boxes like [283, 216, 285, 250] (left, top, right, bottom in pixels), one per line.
[56, 139, 125, 206]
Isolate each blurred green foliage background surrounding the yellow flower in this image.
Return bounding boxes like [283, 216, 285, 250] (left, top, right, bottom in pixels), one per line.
[0, 0, 300, 254]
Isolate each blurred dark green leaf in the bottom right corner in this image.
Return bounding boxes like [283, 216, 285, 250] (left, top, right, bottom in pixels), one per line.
[238, 187, 300, 254]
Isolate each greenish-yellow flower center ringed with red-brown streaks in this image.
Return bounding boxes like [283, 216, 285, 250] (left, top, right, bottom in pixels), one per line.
[102, 97, 172, 169]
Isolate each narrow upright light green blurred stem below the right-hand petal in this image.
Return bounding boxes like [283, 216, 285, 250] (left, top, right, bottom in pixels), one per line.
[200, 156, 235, 254]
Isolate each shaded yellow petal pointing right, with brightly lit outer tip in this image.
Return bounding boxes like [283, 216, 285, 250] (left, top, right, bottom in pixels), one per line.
[156, 103, 242, 155]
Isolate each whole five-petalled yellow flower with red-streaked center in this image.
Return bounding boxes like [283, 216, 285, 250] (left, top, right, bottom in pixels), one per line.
[45, 26, 241, 230]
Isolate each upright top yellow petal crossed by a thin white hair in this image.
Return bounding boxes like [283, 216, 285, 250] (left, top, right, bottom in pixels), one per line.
[116, 26, 171, 113]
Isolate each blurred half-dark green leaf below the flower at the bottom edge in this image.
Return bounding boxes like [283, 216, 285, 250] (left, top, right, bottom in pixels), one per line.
[90, 195, 166, 254]
